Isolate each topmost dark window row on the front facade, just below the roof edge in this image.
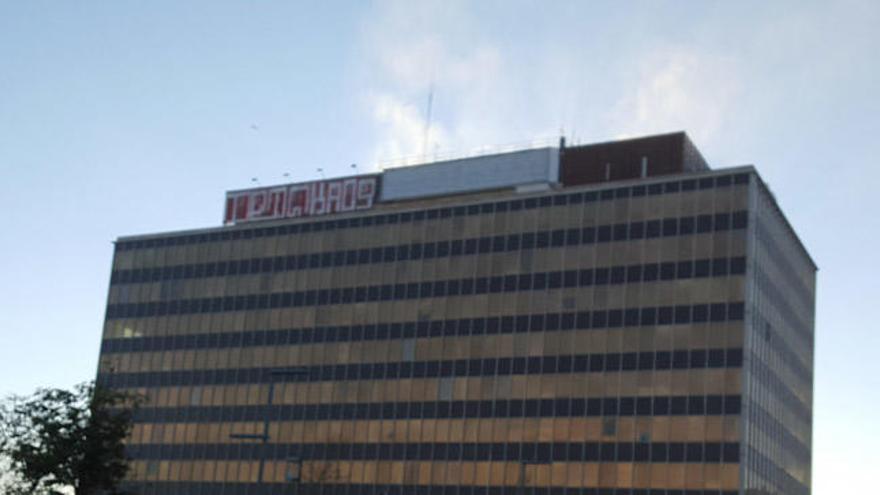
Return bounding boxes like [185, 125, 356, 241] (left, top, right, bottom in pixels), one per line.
[116, 173, 749, 251]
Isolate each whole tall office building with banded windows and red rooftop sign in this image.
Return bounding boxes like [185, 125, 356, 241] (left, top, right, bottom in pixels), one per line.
[98, 133, 816, 495]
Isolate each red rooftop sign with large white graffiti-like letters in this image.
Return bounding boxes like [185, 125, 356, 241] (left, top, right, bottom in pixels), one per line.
[223, 175, 379, 225]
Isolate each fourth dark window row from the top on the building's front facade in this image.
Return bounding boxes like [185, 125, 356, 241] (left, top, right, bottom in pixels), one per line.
[101, 302, 745, 354]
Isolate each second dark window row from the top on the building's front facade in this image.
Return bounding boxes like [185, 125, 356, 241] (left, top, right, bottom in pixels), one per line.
[110, 211, 748, 284]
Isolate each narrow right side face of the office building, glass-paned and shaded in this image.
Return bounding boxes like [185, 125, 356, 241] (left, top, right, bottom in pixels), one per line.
[743, 180, 816, 495]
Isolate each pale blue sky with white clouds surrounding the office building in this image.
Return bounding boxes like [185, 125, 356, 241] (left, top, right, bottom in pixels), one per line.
[0, 0, 880, 494]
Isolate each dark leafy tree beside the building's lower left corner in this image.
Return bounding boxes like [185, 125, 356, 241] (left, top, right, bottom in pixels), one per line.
[0, 382, 142, 495]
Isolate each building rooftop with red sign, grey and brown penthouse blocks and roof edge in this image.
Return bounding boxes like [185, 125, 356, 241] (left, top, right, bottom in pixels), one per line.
[117, 132, 815, 272]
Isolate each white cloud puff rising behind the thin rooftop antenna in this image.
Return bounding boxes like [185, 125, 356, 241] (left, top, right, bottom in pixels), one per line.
[352, 1, 548, 169]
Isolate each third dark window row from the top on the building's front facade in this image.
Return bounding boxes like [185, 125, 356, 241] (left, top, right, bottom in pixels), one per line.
[107, 264, 746, 323]
